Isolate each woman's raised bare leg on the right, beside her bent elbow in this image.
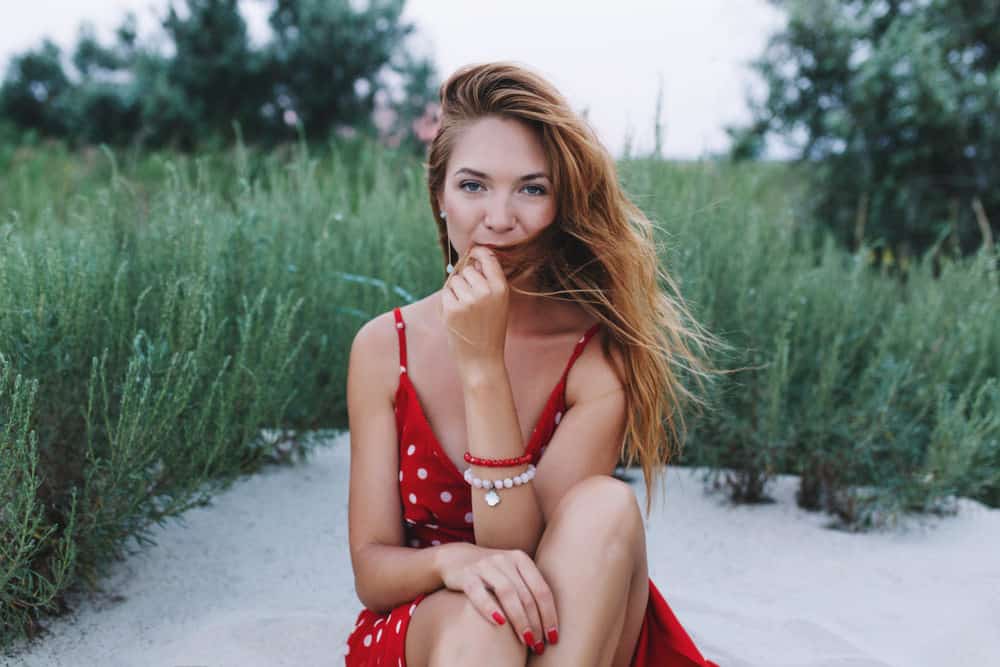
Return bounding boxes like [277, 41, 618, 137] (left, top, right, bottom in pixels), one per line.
[528, 476, 649, 667]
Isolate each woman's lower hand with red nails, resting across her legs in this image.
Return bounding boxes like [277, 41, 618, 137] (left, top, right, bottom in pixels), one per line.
[438, 542, 559, 653]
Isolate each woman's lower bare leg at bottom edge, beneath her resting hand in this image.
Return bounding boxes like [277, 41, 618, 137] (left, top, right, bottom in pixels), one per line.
[406, 589, 527, 667]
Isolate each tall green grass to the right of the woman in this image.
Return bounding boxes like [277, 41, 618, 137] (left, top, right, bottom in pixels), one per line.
[626, 157, 1000, 530]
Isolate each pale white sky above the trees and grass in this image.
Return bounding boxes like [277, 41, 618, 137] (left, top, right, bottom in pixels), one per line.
[0, 0, 783, 158]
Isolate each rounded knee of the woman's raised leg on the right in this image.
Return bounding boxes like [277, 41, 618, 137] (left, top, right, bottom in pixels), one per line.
[550, 475, 645, 544]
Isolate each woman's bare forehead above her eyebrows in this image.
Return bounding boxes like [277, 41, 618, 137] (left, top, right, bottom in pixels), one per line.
[448, 116, 548, 178]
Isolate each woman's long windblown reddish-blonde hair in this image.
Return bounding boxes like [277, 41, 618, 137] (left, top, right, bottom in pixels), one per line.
[425, 62, 728, 514]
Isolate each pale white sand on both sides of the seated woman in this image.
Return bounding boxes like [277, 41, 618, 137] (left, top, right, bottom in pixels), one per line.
[0, 433, 1000, 667]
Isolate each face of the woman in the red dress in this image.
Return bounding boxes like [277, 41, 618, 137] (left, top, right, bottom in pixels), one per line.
[438, 116, 556, 255]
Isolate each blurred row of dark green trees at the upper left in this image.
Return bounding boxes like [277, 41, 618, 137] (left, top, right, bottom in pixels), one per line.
[0, 0, 434, 149]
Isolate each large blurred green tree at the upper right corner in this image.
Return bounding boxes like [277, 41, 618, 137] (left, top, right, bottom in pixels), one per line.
[728, 0, 1000, 255]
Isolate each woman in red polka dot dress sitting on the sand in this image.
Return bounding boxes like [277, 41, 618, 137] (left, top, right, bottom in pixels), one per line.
[346, 63, 716, 667]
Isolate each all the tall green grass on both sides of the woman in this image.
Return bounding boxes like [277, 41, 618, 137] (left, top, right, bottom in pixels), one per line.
[0, 137, 1000, 646]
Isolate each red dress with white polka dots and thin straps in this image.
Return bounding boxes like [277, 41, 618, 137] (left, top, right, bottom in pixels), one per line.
[345, 308, 718, 667]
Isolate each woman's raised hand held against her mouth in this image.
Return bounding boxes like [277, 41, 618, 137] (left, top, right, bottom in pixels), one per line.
[441, 246, 508, 372]
